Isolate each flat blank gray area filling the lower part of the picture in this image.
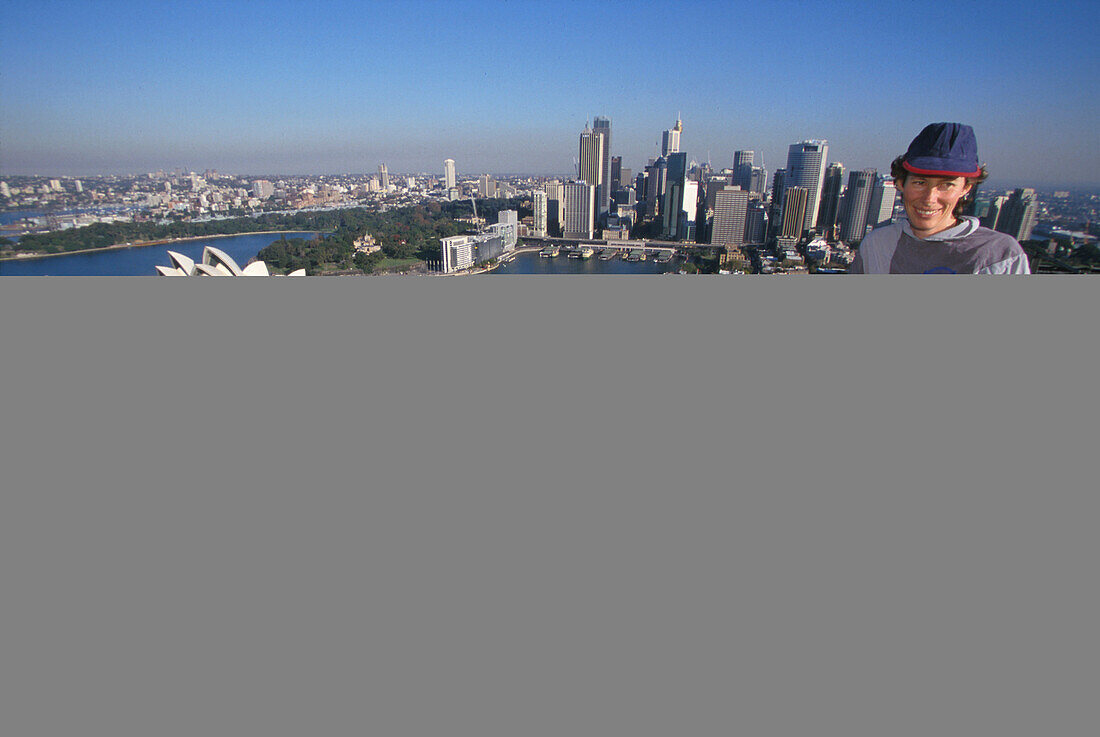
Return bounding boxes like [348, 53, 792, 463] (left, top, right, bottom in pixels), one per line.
[0, 276, 1100, 737]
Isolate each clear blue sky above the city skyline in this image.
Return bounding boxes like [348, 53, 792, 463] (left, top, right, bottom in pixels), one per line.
[0, 0, 1100, 185]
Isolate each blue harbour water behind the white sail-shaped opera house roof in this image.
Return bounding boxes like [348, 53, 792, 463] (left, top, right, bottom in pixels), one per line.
[0, 232, 317, 276]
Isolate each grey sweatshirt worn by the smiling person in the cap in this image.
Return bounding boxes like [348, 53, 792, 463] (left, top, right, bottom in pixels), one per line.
[848, 217, 1031, 274]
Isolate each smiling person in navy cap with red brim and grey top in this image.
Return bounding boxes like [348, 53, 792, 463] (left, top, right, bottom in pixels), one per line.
[848, 123, 1031, 274]
